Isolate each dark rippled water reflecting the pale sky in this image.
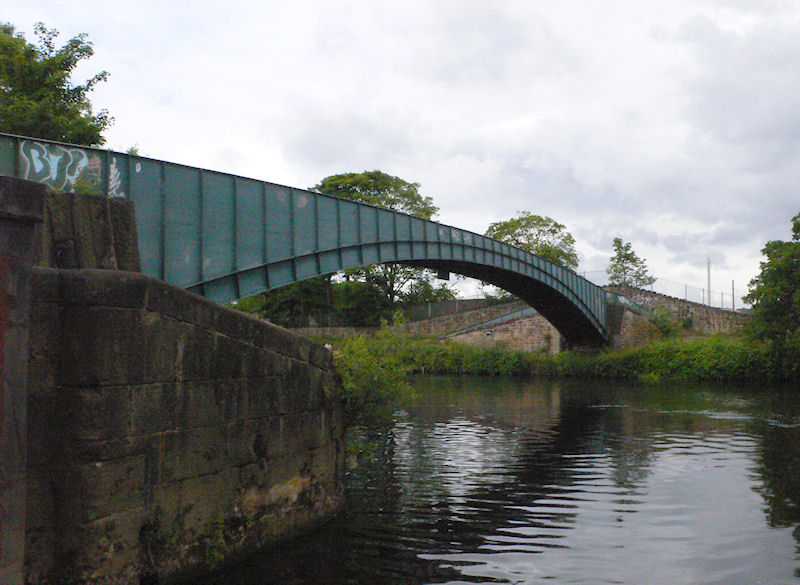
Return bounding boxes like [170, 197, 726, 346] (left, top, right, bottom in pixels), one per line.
[204, 377, 800, 585]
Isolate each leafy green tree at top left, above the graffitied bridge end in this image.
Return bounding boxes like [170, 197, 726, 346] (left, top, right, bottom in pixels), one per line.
[0, 22, 112, 146]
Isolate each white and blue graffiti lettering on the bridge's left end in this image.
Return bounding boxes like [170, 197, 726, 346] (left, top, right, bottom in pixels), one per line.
[19, 140, 125, 197]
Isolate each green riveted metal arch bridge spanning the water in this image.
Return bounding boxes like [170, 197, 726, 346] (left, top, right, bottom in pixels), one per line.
[0, 134, 618, 345]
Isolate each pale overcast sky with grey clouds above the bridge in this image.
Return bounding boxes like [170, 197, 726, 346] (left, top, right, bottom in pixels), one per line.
[6, 0, 800, 302]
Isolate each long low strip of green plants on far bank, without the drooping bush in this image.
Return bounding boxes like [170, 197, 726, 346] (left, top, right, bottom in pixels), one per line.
[333, 334, 800, 381]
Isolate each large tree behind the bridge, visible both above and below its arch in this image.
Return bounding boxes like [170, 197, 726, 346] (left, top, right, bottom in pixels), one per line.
[311, 170, 455, 310]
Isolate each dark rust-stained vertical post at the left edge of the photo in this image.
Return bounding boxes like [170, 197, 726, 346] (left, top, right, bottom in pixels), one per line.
[0, 177, 46, 585]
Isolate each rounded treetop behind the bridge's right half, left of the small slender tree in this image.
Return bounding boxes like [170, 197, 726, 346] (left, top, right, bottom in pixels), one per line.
[486, 211, 578, 270]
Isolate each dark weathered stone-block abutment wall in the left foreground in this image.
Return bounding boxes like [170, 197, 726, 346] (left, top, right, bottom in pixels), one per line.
[26, 268, 343, 585]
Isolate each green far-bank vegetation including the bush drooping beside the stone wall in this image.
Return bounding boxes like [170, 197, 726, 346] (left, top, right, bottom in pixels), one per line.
[329, 330, 800, 422]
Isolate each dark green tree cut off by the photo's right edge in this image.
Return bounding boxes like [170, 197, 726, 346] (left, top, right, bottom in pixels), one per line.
[744, 213, 800, 361]
